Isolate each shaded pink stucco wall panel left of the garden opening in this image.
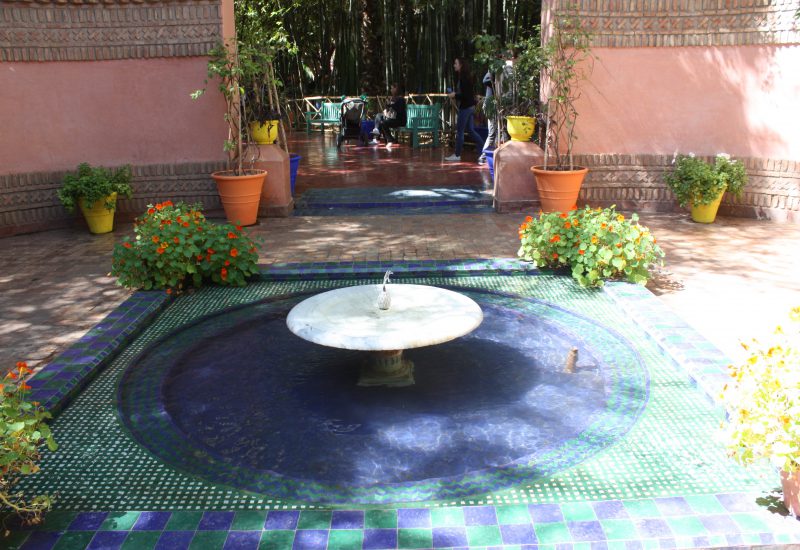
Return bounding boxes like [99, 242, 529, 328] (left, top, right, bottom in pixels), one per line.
[0, 57, 227, 174]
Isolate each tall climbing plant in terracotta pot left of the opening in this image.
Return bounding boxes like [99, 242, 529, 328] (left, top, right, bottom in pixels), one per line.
[192, 40, 267, 225]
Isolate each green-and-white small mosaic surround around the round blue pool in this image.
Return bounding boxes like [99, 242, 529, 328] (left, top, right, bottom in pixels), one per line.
[17, 265, 772, 510]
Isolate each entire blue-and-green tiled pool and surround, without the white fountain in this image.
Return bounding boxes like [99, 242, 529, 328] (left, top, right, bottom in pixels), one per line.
[9, 260, 800, 548]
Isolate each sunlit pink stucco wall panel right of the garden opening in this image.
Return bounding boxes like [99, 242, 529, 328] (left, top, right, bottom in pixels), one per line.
[576, 46, 800, 160]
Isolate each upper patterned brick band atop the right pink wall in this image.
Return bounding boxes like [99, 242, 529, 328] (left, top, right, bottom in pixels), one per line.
[554, 0, 800, 48]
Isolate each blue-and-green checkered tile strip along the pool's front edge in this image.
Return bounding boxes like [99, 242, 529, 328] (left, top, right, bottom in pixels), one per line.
[10, 500, 800, 550]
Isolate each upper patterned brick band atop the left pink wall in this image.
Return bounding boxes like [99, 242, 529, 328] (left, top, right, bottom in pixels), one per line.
[0, 0, 222, 62]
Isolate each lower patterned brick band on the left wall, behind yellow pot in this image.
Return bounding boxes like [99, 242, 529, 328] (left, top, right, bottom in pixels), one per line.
[0, 162, 226, 237]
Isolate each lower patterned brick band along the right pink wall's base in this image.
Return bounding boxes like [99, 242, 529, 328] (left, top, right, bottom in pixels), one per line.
[576, 155, 800, 223]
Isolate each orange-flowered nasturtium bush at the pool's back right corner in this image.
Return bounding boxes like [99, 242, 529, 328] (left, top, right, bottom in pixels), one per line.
[518, 206, 664, 286]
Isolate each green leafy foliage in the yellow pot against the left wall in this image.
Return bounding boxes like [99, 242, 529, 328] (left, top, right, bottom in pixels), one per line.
[58, 162, 133, 212]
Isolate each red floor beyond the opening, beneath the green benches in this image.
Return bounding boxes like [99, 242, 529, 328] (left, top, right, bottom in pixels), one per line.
[289, 131, 492, 196]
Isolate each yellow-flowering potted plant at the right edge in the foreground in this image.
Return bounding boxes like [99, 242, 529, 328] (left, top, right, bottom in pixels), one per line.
[722, 307, 800, 516]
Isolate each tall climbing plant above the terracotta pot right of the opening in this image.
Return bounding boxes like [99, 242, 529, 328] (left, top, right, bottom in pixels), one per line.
[541, 10, 594, 170]
